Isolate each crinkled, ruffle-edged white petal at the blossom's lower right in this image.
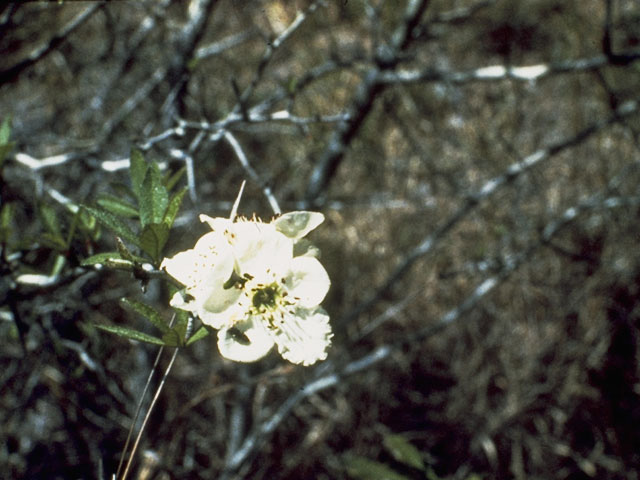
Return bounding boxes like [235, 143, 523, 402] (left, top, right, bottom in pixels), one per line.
[272, 308, 333, 365]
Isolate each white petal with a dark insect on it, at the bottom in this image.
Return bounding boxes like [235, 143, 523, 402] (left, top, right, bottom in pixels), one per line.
[218, 318, 273, 362]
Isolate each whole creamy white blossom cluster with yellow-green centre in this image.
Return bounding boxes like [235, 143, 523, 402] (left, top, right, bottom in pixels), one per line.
[162, 212, 332, 365]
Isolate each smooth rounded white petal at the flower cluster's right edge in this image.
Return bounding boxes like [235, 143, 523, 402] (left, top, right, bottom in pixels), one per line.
[285, 257, 331, 308]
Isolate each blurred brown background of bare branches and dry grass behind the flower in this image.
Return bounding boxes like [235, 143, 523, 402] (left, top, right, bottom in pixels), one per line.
[0, 0, 640, 479]
